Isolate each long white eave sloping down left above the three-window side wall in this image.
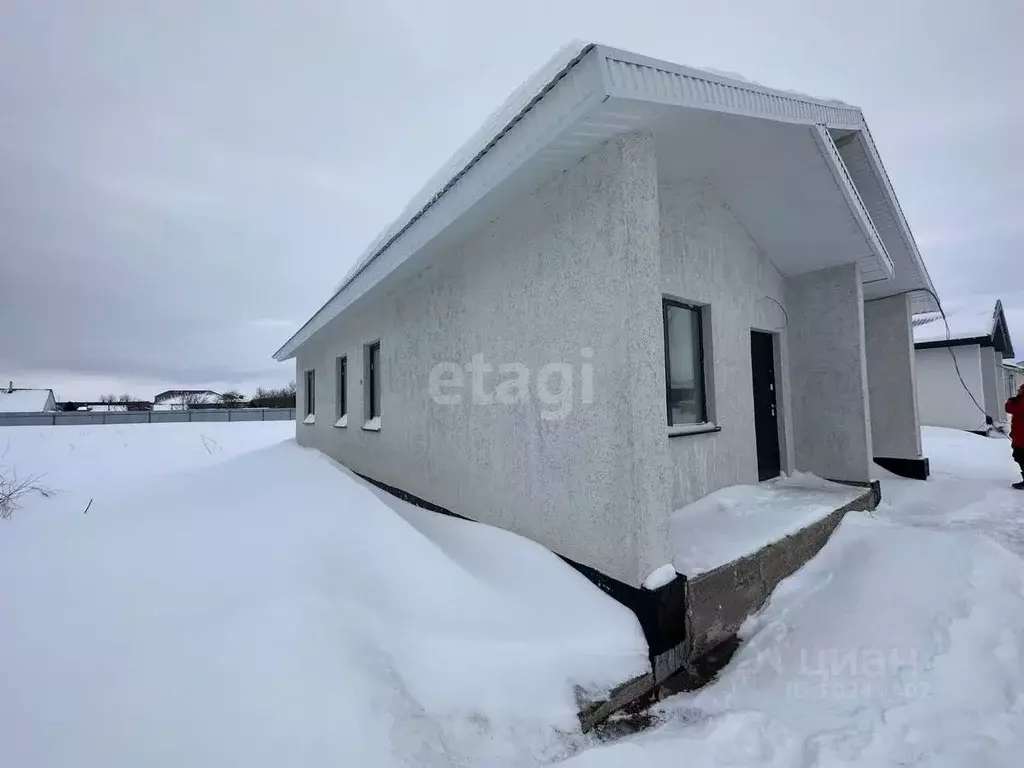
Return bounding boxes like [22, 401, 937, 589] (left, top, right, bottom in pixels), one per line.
[273, 45, 604, 361]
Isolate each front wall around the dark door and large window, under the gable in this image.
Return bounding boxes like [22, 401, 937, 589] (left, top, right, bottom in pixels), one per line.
[659, 177, 793, 508]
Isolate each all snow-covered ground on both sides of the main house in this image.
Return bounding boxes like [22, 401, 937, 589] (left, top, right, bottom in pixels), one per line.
[0, 423, 1024, 768]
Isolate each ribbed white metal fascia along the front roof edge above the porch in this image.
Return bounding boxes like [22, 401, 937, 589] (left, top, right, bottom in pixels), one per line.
[597, 45, 864, 129]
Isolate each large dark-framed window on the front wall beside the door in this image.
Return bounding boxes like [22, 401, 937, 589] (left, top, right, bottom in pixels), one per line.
[664, 299, 708, 427]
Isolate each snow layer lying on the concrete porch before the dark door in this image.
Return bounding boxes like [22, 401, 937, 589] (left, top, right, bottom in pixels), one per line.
[670, 472, 865, 577]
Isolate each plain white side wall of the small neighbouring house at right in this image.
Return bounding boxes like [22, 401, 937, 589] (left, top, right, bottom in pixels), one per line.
[914, 344, 985, 430]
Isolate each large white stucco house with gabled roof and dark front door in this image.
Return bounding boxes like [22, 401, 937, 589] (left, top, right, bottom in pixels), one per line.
[274, 44, 936, 692]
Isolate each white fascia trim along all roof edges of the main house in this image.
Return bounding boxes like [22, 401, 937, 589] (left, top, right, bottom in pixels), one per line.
[273, 44, 934, 361]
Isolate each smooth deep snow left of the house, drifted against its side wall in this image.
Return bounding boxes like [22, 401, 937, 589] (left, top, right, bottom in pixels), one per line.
[0, 424, 648, 768]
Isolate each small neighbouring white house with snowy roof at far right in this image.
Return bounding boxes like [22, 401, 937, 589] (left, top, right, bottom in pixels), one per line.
[913, 301, 1016, 433]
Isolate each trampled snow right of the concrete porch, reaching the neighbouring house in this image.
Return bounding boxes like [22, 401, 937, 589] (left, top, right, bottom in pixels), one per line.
[567, 428, 1024, 768]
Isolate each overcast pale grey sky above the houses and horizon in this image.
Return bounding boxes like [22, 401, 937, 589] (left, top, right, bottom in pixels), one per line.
[0, 0, 1024, 398]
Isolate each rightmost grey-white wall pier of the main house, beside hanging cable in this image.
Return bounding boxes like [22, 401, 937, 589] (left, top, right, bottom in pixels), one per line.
[864, 295, 921, 459]
